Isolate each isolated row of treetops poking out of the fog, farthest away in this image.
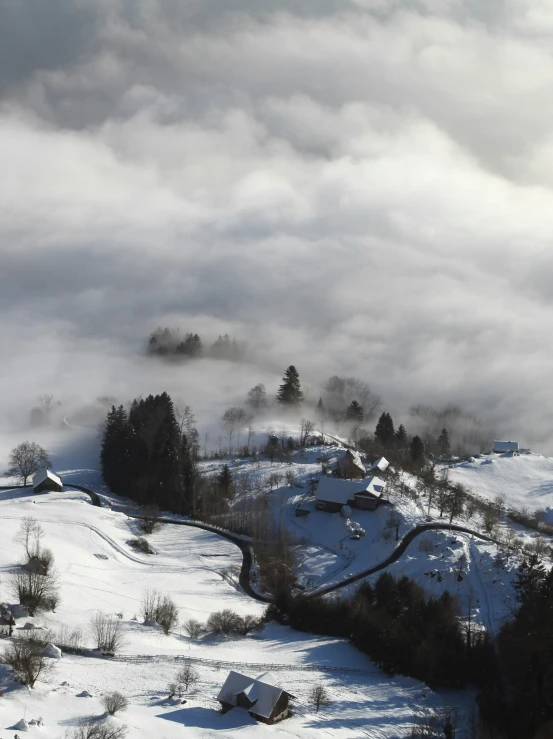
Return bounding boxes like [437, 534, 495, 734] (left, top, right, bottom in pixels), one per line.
[148, 327, 246, 362]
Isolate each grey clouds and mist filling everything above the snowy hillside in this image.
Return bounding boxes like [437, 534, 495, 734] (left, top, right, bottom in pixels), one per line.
[0, 0, 553, 452]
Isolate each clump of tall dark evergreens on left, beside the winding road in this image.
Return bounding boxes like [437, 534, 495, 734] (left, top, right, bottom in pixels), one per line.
[100, 393, 197, 513]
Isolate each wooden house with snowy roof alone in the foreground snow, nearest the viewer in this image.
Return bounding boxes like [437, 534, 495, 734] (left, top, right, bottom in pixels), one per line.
[217, 670, 295, 724]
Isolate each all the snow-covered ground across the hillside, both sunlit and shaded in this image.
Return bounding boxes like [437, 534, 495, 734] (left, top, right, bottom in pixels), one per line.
[0, 429, 553, 739]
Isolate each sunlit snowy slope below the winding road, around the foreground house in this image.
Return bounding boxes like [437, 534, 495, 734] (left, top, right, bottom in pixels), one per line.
[0, 491, 471, 739]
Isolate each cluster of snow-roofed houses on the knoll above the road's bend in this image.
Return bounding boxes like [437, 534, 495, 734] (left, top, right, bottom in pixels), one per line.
[315, 449, 389, 514]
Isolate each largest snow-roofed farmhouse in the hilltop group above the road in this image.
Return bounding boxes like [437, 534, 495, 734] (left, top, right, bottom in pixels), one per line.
[315, 477, 386, 513]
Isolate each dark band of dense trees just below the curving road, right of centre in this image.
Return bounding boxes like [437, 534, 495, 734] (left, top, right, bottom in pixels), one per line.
[267, 573, 495, 687]
